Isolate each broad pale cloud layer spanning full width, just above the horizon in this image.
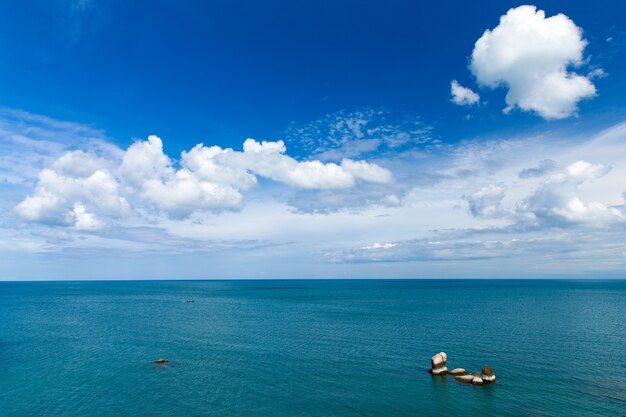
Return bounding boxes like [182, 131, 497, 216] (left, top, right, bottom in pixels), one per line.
[0, 109, 626, 278]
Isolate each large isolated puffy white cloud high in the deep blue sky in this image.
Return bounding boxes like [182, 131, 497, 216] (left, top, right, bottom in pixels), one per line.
[470, 6, 596, 119]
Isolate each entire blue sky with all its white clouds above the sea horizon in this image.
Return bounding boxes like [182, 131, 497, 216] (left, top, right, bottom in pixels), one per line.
[0, 0, 626, 280]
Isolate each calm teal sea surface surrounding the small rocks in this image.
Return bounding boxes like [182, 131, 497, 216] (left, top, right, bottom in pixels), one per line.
[0, 280, 626, 417]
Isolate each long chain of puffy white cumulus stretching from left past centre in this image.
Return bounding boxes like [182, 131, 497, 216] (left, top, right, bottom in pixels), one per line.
[15, 135, 393, 223]
